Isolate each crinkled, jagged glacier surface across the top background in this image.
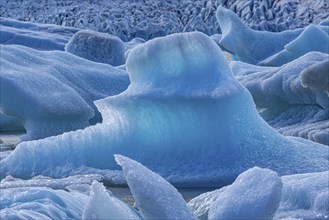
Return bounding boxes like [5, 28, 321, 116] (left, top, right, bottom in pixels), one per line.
[0, 0, 329, 40]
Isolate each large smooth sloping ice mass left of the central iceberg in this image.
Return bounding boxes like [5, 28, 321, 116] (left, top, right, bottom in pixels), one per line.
[0, 45, 129, 140]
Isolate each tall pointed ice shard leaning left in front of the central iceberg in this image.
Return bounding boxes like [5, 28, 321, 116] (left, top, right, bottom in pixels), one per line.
[115, 155, 195, 219]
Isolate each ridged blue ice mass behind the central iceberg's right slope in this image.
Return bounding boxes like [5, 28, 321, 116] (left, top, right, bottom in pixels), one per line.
[230, 52, 329, 145]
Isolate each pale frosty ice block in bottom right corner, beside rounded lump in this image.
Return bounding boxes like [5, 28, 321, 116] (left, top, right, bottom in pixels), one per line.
[274, 171, 329, 219]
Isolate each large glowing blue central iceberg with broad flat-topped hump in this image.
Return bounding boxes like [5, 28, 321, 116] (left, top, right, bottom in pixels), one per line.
[0, 32, 328, 186]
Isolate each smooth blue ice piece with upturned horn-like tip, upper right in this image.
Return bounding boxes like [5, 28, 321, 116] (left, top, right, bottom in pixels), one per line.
[216, 6, 303, 64]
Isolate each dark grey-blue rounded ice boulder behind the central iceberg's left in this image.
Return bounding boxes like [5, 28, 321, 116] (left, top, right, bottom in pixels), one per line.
[65, 30, 126, 66]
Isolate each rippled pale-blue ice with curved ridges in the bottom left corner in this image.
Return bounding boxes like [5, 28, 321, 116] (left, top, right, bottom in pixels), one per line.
[0, 187, 88, 220]
